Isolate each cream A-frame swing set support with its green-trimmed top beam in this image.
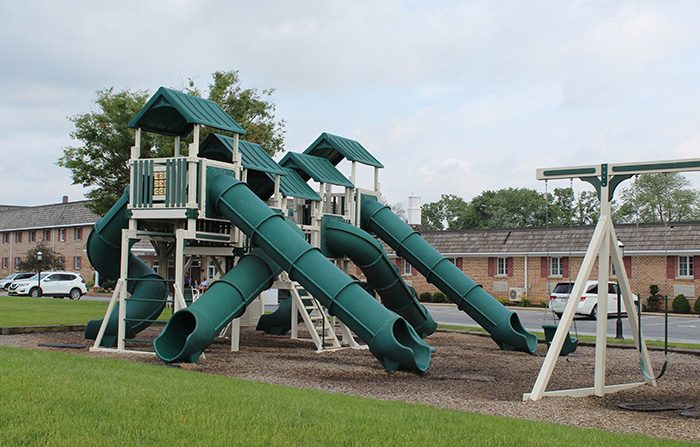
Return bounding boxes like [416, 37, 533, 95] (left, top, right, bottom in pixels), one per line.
[523, 159, 700, 401]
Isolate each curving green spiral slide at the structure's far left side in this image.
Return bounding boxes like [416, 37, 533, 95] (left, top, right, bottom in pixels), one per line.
[85, 191, 168, 347]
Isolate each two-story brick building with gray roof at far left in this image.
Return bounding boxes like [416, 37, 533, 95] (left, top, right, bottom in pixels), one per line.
[0, 200, 99, 280]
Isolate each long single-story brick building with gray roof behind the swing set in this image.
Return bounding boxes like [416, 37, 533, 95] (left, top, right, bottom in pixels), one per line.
[387, 222, 700, 303]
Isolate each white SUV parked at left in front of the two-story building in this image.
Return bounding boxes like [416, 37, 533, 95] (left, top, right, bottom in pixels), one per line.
[9, 272, 87, 300]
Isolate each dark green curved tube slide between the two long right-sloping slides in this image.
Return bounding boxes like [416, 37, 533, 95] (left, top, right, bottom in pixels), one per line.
[321, 216, 437, 338]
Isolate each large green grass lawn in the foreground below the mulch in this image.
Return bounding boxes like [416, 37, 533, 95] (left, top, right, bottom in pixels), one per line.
[0, 347, 684, 447]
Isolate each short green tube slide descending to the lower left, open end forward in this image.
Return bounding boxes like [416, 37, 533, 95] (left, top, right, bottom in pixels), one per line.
[153, 250, 282, 363]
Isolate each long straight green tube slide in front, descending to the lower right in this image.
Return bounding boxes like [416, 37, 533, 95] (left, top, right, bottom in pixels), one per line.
[207, 171, 433, 372]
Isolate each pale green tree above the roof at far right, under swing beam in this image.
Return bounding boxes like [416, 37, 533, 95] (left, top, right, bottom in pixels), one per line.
[621, 172, 700, 223]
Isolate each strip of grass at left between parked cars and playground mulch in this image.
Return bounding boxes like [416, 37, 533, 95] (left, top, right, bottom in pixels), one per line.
[0, 296, 171, 327]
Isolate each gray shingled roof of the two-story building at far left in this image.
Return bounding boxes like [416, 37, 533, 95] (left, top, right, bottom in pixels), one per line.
[0, 200, 100, 231]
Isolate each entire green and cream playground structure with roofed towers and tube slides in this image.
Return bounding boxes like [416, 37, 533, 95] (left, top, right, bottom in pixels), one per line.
[85, 87, 537, 372]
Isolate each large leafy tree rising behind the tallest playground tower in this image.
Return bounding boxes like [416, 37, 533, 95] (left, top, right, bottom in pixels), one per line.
[57, 71, 285, 214]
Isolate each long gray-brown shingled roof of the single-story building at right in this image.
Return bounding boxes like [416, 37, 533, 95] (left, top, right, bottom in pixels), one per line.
[386, 222, 700, 256]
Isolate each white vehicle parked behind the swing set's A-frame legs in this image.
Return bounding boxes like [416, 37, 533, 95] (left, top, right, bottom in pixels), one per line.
[549, 281, 639, 319]
